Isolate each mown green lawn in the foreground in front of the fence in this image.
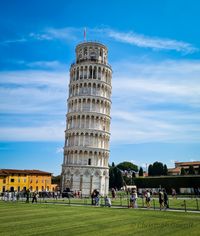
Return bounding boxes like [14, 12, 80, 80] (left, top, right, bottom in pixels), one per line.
[0, 202, 200, 236]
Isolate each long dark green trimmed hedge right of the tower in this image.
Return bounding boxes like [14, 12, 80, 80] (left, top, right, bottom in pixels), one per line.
[133, 175, 200, 191]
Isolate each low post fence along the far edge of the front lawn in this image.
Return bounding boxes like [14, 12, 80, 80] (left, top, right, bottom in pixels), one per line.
[0, 196, 200, 211]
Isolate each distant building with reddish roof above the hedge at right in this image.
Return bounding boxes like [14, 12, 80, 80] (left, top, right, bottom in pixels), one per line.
[168, 161, 200, 175]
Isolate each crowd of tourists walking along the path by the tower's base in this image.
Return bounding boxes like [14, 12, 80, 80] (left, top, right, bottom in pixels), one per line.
[1, 187, 188, 210]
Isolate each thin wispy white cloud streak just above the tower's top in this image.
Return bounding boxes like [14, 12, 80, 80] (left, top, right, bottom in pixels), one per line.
[46, 27, 198, 54]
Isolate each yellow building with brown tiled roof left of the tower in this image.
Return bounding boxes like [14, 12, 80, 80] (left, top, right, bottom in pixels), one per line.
[0, 169, 52, 192]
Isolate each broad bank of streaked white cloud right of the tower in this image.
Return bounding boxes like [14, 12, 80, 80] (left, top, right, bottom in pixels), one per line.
[111, 61, 200, 143]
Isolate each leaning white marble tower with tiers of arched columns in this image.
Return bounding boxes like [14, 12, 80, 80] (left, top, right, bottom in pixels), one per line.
[62, 42, 112, 196]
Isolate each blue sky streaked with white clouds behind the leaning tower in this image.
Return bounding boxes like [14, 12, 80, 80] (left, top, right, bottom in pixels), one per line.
[0, 0, 200, 175]
